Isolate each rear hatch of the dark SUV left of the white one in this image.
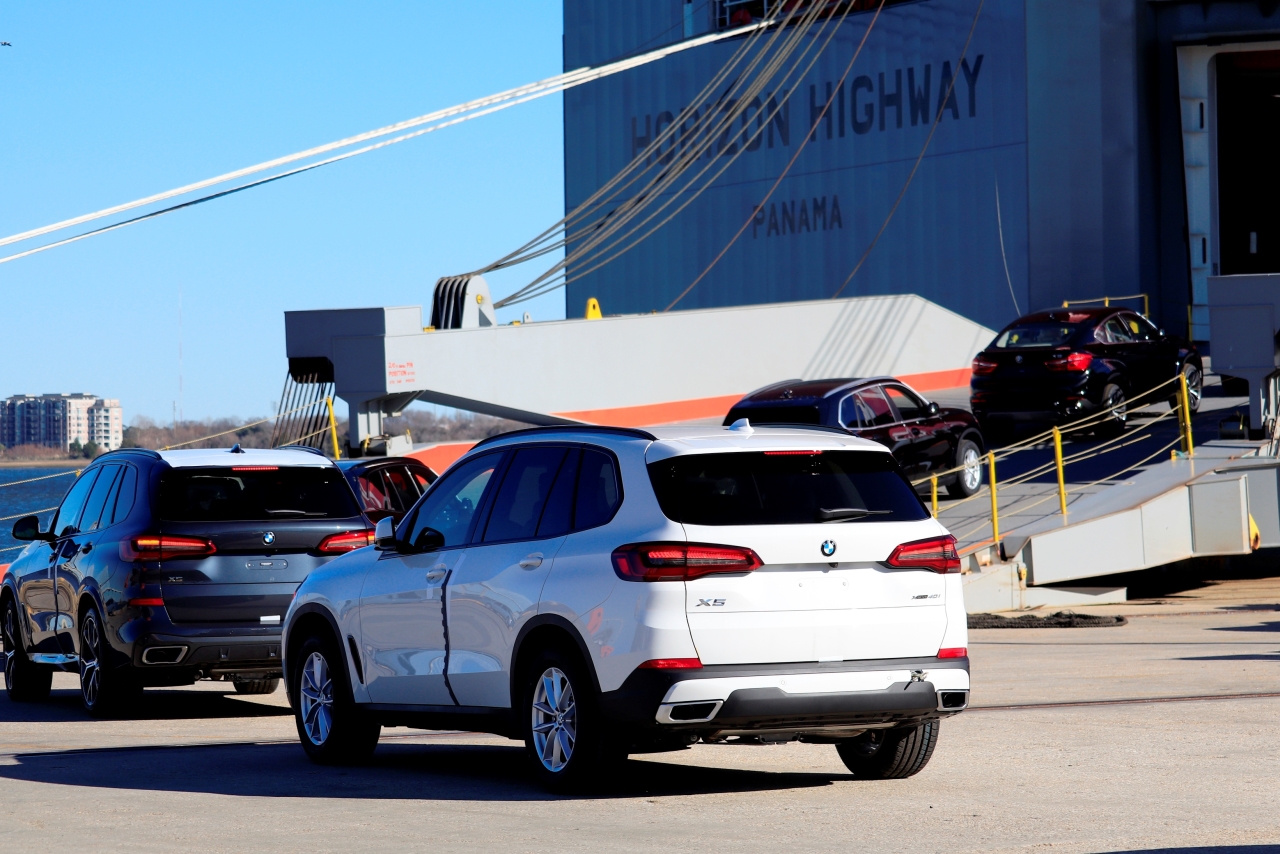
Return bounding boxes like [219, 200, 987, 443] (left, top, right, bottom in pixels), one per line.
[147, 465, 367, 625]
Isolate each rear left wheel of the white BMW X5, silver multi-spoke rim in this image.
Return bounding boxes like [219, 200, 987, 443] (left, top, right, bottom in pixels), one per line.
[520, 648, 623, 791]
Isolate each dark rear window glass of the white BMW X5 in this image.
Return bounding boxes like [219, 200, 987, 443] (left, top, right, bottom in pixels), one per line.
[649, 451, 928, 525]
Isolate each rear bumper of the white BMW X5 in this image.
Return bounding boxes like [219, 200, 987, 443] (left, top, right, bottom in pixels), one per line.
[602, 658, 969, 736]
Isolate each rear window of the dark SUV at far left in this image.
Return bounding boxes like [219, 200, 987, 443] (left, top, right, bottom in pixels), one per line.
[156, 466, 360, 522]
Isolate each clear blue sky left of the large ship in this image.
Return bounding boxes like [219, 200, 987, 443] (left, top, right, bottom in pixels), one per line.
[0, 0, 577, 421]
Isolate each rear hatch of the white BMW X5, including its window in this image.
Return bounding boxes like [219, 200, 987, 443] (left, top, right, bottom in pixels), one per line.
[649, 449, 947, 665]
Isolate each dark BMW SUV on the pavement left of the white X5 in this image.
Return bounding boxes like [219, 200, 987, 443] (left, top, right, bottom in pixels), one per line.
[0, 446, 372, 714]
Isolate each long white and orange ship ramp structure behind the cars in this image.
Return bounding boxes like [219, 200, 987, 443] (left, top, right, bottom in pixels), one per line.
[284, 286, 995, 453]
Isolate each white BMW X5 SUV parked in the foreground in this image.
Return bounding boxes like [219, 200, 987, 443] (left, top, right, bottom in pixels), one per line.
[283, 423, 969, 787]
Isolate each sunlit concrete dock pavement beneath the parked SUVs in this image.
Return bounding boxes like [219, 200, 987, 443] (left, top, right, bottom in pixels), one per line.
[0, 579, 1280, 854]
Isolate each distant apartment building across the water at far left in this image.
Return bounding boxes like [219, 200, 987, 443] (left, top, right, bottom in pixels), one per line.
[0, 393, 124, 451]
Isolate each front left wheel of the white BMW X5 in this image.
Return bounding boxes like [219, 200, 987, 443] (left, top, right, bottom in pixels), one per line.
[289, 634, 373, 766]
